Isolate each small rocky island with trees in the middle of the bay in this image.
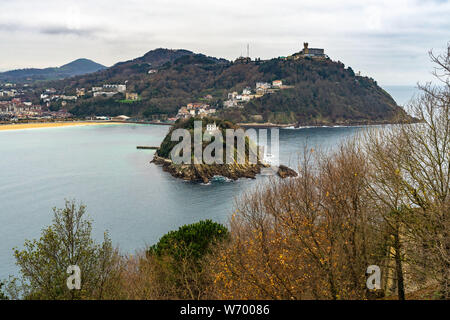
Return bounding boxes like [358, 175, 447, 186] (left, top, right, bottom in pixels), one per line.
[152, 118, 297, 183]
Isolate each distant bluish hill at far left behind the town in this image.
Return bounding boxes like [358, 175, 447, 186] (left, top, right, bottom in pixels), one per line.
[0, 59, 106, 82]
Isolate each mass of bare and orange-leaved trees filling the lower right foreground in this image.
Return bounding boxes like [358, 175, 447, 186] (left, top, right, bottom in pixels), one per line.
[210, 43, 450, 299]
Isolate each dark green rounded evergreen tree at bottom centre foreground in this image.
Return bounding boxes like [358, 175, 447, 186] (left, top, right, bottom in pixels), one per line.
[147, 220, 228, 300]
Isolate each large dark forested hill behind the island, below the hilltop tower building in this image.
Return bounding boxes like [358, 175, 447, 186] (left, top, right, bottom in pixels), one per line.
[40, 49, 405, 124]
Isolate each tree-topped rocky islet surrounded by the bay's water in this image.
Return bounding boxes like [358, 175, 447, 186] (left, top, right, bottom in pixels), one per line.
[152, 117, 297, 183]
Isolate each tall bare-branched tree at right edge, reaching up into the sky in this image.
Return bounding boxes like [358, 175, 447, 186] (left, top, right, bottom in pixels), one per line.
[366, 44, 450, 299]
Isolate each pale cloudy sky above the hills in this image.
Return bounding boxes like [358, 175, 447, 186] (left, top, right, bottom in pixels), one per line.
[0, 0, 450, 85]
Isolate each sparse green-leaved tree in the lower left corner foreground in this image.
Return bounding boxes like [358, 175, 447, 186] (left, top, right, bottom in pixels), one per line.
[14, 201, 118, 300]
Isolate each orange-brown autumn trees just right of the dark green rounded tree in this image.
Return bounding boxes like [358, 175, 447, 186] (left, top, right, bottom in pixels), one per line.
[210, 143, 381, 300]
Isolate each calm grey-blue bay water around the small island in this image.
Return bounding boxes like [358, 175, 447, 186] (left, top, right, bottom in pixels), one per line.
[0, 125, 370, 279]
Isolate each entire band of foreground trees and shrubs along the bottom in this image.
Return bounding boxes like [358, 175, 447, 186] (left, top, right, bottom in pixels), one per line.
[2, 47, 450, 300]
